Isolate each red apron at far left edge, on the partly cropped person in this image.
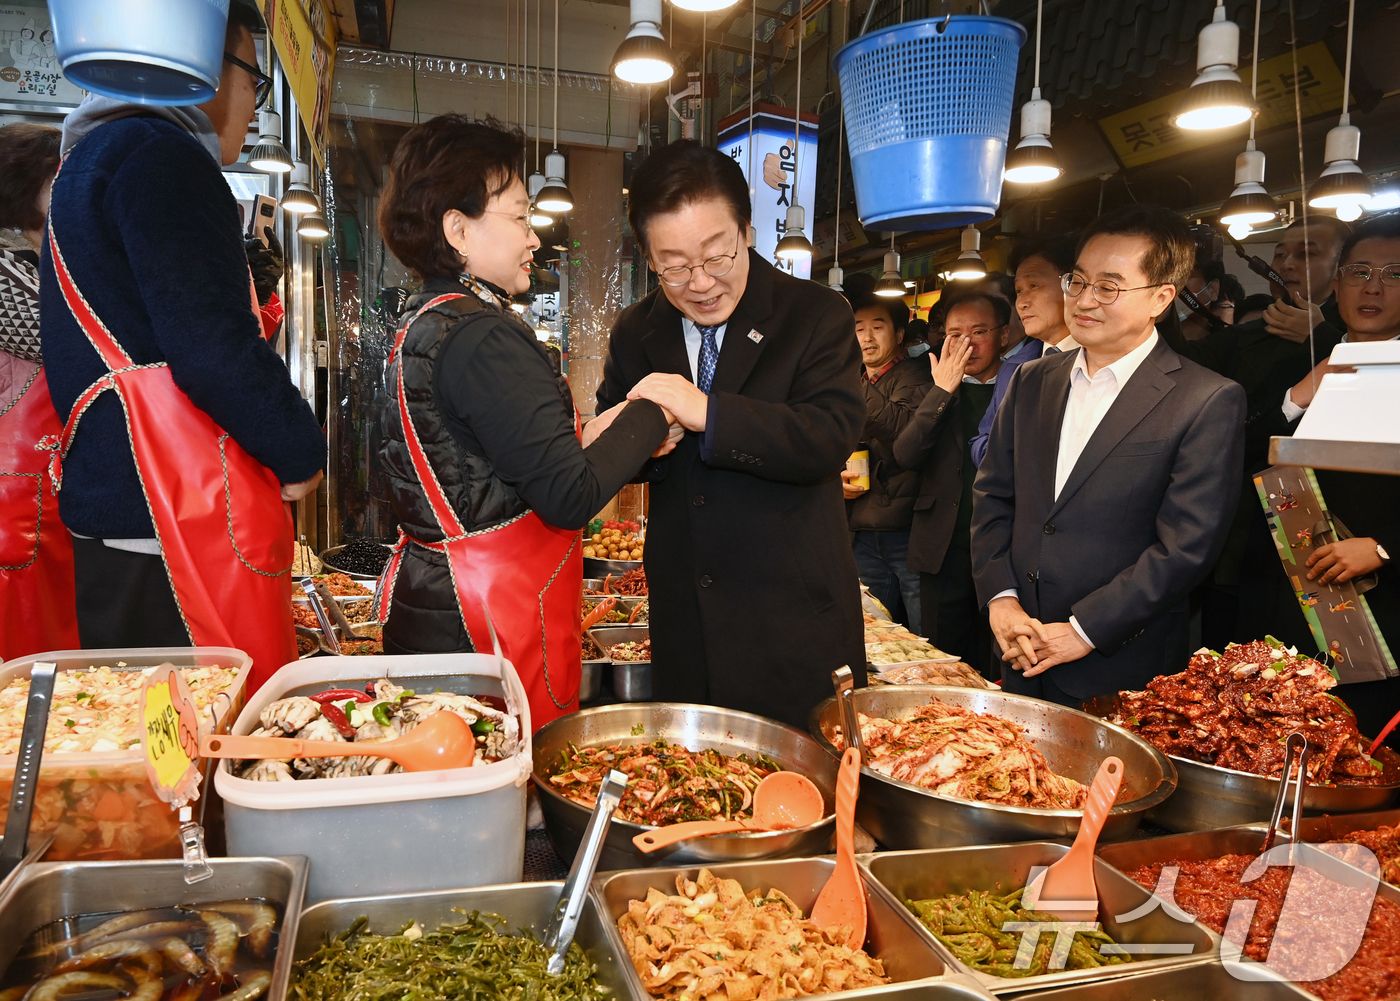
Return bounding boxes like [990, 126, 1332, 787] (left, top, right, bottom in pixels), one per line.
[0, 368, 78, 661]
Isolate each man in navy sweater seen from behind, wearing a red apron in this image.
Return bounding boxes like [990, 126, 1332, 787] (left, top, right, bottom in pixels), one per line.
[41, 0, 326, 649]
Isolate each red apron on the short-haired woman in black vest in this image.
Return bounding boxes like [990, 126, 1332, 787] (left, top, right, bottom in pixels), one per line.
[377, 295, 584, 729]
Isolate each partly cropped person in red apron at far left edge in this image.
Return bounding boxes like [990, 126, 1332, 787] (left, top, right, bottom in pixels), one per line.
[0, 123, 78, 661]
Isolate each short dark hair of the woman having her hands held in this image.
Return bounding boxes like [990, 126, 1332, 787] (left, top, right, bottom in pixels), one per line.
[379, 115, 525, 279]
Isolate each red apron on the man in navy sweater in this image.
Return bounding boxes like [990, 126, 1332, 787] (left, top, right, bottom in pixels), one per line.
[49, 225, 297, 694]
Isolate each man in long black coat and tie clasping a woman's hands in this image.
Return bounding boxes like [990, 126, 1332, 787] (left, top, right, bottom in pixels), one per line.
[598, 141, 865, 728]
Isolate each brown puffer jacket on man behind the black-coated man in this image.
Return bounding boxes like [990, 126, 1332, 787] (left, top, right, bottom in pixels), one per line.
[846, 358, 934, 532]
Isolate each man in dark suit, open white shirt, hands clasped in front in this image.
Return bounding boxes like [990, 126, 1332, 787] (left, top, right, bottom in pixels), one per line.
[972, 206, 1245, 706]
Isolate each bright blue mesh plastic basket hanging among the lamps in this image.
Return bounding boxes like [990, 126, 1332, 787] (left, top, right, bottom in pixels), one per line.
[836, 15, 1026, 230]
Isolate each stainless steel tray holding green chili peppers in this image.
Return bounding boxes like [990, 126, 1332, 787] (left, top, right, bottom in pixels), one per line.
[860, 841, 1219, 995]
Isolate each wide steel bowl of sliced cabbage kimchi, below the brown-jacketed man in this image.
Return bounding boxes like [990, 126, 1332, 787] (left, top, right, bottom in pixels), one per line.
[809, 685, 1176, 850]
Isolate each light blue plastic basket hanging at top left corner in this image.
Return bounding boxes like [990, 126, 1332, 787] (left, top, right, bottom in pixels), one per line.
[49, 0, 228, 105]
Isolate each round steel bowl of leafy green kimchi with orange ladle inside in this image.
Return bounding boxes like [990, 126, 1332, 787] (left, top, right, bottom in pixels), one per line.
[533, 703, 837, 871]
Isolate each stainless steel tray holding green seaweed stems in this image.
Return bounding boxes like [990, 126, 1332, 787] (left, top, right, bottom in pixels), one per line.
[293, 882, 647, 1001]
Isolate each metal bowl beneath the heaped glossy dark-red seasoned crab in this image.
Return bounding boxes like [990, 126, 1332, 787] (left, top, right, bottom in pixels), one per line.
[1084, 696, 1400, 832]
